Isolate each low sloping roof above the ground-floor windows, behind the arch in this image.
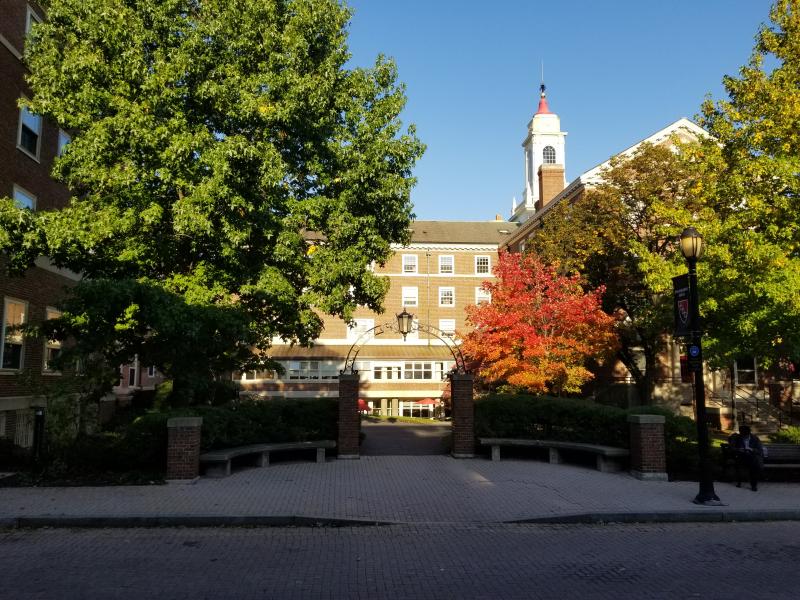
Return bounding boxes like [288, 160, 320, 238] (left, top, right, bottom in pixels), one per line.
[269, 341, 453, 360]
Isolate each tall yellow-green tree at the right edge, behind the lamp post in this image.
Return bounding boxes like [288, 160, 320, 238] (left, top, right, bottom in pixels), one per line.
[697, 0, 800, 366]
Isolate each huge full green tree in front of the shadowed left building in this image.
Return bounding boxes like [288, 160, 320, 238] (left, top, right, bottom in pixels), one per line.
[0, 0, 424, 404]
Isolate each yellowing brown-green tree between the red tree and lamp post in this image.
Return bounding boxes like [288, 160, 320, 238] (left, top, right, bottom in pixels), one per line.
[528, 142, 707, 404]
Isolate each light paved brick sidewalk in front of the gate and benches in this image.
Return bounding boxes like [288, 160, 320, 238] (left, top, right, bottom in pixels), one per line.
[0, 456, 800, 527]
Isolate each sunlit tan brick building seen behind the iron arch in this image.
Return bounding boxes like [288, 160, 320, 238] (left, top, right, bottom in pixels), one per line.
[237, 218, 516, 417]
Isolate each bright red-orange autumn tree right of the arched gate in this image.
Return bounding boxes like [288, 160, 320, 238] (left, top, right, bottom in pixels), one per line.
[462, 252, 617, 395]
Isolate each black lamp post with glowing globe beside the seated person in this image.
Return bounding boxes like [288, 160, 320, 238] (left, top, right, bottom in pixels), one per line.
[681, 227, 722, 506]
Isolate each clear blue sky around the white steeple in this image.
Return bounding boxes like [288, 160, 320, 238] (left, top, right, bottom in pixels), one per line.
[347, 0, 771, 220]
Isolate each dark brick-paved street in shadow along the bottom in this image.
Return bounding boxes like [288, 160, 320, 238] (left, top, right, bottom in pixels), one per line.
[0, 523, 800, 600]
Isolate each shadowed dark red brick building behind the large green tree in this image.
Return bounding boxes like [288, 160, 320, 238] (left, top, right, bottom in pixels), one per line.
[0, 0, 77, 447]
